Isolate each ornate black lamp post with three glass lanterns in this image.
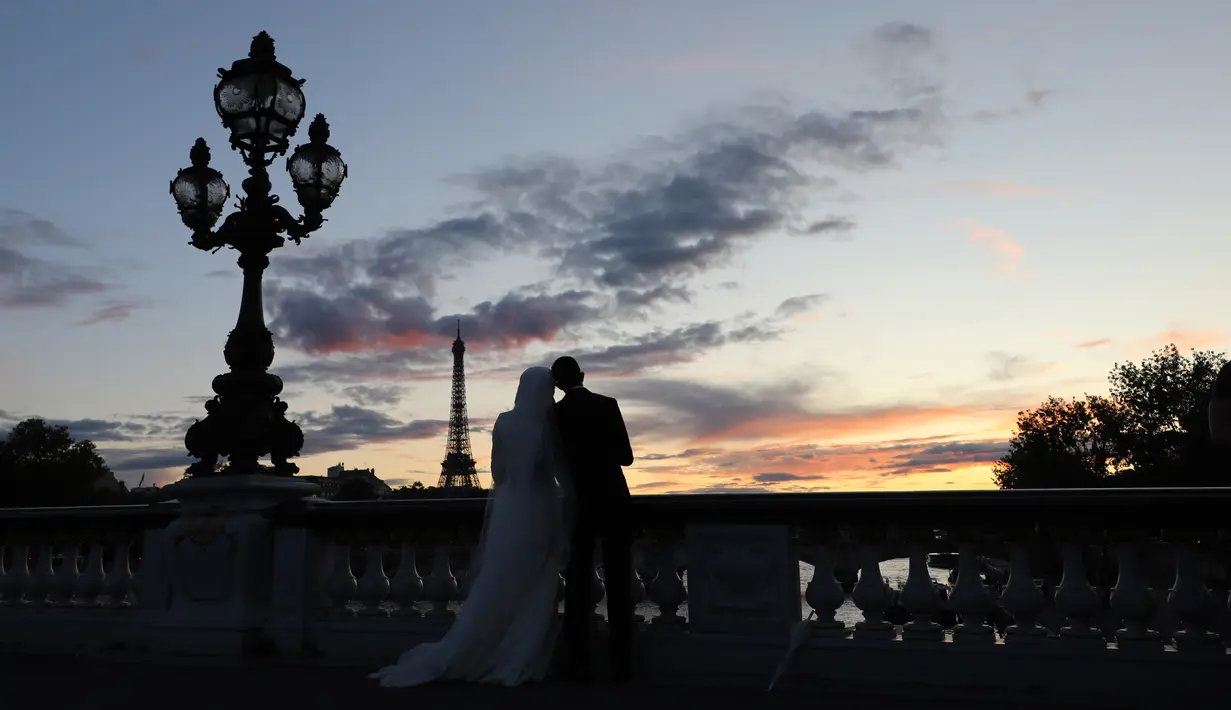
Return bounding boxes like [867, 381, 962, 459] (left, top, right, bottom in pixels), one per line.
[171, 32, 346, 476]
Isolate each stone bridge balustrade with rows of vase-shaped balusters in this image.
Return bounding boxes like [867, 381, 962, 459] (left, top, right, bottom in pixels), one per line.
[0, 479, 1231, 706]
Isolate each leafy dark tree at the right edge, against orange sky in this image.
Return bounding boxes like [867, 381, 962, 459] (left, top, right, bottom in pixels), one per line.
[992, 345, 1231, 489]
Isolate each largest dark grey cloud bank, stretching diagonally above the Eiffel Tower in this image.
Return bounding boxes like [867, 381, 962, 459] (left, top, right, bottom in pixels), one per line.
[267, 37, 948, 353]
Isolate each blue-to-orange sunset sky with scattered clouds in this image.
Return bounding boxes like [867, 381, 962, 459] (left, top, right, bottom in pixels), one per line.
[0, 0, 1231, 492]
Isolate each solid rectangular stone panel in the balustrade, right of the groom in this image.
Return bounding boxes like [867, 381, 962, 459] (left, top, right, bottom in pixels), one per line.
[684, 525, 803, 636]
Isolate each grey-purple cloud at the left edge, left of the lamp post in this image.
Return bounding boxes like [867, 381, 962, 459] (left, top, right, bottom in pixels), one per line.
[0, 209, 114, 309]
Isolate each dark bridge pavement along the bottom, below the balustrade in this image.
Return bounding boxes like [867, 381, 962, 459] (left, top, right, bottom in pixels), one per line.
[0, 655, 1091, 710]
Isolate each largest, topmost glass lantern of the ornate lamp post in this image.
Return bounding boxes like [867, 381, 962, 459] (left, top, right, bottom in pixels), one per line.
[214, 32, 305, 156]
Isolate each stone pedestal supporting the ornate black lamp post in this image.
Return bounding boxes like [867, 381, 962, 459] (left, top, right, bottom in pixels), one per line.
[146, 475, 319, 656]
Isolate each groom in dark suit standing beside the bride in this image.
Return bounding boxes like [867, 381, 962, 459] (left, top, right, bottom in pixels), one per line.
[551, 357, 633, 683]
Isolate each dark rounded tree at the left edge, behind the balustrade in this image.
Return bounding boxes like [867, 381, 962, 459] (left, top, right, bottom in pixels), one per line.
[0, 417, 123, 507]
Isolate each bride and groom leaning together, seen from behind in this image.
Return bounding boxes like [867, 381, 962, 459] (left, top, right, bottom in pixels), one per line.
[372, 357, 633, 688]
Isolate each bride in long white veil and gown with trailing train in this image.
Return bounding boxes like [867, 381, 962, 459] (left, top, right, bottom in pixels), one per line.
[371, 368, 571, 688]
